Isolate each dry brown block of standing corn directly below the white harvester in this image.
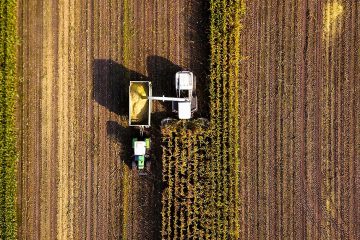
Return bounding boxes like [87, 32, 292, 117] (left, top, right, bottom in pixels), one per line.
[162, 120, 210, 239]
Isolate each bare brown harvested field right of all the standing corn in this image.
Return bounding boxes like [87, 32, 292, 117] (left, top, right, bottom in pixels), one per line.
[240, 0, 360, 239]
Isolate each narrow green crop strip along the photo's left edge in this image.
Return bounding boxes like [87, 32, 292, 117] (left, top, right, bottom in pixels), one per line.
[0, 0, 17, 239]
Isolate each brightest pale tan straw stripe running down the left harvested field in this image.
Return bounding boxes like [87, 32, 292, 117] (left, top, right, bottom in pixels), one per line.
[57, 1, 73, 239]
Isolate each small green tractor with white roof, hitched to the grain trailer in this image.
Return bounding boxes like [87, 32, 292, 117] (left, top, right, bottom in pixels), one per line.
[132, 138, 151, 175]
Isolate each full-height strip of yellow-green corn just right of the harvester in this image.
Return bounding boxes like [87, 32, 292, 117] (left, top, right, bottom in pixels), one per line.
[209, 0, 245, 239]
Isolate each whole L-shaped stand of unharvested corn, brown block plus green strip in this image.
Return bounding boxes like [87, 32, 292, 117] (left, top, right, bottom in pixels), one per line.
[162, 0, 245, 239]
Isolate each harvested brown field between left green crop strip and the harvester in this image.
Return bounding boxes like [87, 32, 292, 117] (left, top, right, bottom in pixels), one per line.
[17, 0, 208, 239]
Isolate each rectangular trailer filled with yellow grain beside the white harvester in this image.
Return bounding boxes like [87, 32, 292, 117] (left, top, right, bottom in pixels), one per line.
[129, 81, 152, 127]
